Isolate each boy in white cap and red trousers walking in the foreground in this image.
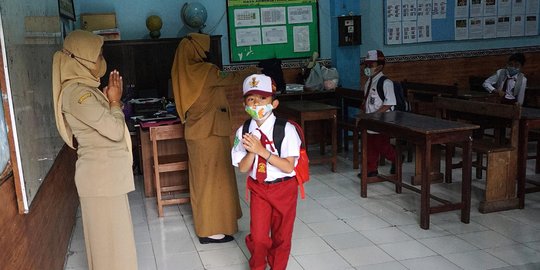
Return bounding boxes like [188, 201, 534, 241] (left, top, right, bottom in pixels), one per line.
[231, 74, 301, 270]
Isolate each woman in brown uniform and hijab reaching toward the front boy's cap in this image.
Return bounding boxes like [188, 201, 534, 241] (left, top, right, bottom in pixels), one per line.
[171, 33, 258, 244]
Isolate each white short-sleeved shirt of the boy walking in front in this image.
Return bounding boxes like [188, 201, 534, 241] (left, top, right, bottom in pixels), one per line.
[231, 113, 302, 182]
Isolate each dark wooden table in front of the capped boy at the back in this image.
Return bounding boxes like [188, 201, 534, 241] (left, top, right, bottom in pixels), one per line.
[358, 111, 478, 230]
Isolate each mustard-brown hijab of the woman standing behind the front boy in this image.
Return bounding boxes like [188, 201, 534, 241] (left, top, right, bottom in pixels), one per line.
[171, 33, 214, 122]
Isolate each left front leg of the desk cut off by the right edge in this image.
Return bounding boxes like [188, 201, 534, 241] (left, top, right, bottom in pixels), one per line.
[517, 121, 529, 209]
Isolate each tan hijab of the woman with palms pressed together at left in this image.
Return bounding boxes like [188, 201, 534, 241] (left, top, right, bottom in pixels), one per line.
[52, 30, 131, 158]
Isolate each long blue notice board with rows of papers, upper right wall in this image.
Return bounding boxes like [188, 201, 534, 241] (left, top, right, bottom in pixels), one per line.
[384, 0, 540, 45]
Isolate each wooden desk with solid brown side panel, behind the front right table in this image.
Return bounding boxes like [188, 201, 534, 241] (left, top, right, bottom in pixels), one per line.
[434, 97, 521, 213]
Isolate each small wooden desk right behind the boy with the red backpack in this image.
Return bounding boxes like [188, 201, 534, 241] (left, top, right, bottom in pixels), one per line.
[276, 100, 339, 172]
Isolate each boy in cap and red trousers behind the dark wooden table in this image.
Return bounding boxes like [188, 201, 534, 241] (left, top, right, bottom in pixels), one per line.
[358, 50, 396, 177]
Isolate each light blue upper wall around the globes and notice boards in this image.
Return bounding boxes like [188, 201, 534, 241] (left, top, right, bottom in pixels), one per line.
[76, 0, 540, 89]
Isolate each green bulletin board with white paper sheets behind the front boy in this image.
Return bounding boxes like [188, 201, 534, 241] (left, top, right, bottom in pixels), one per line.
[227, 0, 319, 62]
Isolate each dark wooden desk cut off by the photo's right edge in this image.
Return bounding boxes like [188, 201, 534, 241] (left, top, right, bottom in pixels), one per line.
[517, 107, 540, 209]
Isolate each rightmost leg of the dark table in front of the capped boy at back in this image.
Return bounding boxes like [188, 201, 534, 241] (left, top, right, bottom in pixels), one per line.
[461, 138, 472, 224]
